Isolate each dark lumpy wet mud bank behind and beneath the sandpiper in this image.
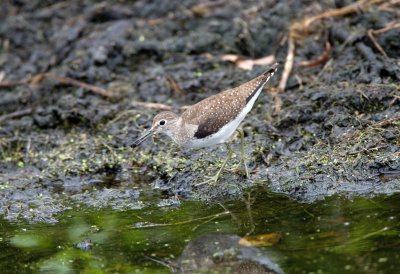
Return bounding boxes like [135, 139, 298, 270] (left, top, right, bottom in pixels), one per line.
[0, 0, 400, 222]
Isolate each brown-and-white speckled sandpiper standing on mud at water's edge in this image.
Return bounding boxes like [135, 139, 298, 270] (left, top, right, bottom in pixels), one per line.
[132, 63, 278, 183]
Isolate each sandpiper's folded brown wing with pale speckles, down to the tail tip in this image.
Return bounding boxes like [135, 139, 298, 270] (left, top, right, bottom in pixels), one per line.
[182, 66, 276, 139]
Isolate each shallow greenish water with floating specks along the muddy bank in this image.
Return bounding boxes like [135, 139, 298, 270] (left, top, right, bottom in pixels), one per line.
[0, 188, 400, 273]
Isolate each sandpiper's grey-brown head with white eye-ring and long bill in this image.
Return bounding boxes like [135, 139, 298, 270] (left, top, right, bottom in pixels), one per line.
[131, 111, 179, 147]
